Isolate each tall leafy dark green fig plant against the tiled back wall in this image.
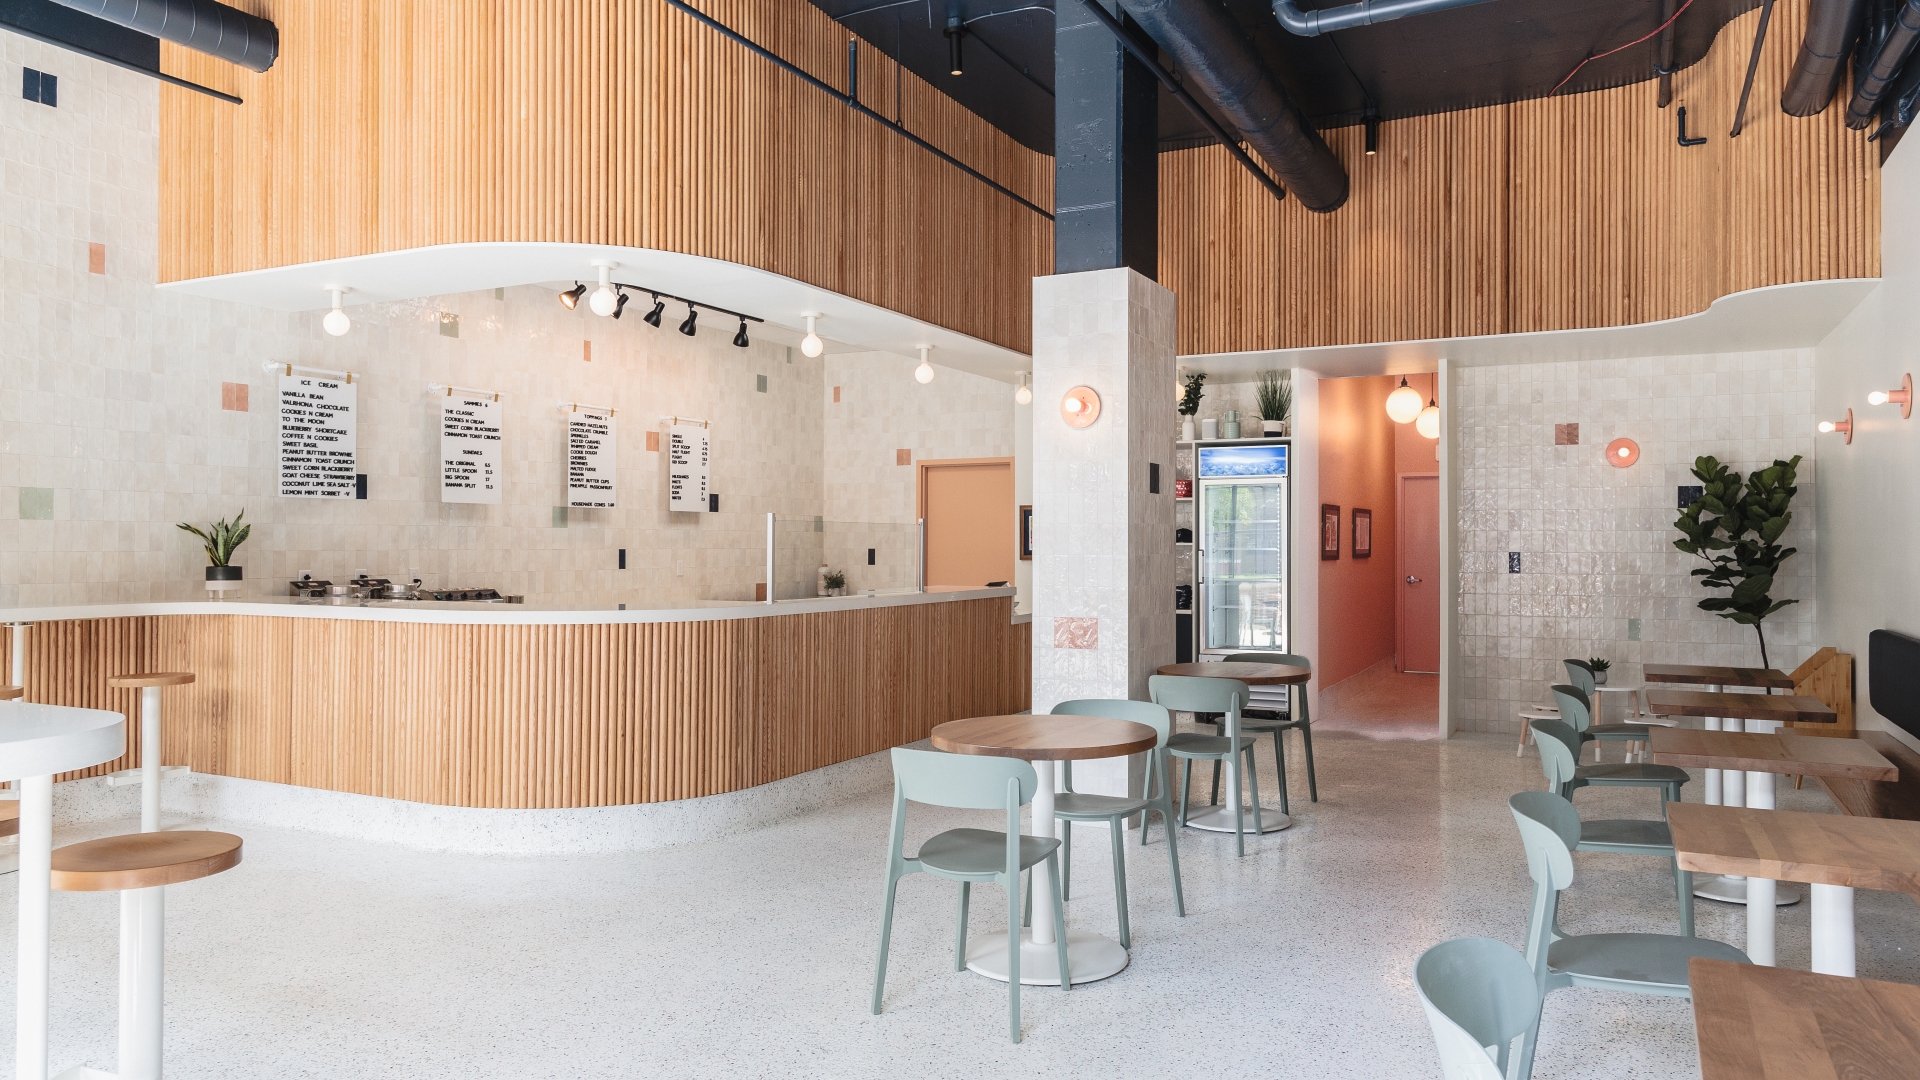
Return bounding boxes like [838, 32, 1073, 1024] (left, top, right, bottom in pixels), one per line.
[1674, 454, 1801, 667]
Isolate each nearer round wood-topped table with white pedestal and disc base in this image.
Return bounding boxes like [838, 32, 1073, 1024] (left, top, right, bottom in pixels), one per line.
[933, 715, 1160, 986]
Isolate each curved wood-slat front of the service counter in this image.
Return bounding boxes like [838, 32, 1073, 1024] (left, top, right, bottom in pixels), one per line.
[11, 598, 1031, 807]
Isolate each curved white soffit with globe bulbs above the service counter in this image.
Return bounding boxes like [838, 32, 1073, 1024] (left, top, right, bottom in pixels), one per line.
[159, 242, 1033, 382]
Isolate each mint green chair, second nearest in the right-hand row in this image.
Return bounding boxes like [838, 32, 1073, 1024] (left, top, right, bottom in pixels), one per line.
[1507, 787, 1749, 1076]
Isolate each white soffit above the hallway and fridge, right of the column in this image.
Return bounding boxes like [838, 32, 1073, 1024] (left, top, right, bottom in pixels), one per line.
[1179, 277, 1880, 379]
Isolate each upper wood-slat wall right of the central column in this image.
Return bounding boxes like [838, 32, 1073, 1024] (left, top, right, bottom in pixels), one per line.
[1160, 0, 1880, 356]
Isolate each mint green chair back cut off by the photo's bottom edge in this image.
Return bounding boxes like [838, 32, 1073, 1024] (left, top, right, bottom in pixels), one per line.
[1413, 938, 1540, 1080]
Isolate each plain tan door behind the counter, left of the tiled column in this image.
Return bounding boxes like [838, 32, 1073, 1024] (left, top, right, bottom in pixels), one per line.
[920, 457, 1016, 586]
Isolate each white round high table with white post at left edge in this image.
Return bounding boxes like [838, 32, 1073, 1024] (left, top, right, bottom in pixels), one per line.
[0, 703, 127, 1080]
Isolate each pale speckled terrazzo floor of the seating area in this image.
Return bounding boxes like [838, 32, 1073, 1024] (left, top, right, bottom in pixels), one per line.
[0, 732, 1920, 1080]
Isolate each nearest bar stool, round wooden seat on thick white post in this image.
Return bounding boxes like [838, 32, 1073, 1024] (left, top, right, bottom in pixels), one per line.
[54, 830, 240, 1080]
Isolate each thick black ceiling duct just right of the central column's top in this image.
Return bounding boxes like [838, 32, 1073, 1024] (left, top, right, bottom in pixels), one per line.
[1119, 0, 1344, 213]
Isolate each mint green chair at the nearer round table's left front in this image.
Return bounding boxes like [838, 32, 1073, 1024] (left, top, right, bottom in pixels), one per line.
[874, 746, 1073, 1042]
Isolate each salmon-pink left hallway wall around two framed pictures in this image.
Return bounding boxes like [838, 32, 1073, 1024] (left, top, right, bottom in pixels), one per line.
[1300, 375, 1405, 688]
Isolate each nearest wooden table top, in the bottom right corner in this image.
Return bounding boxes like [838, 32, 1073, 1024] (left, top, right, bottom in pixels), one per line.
[1688, 959, 1920, 1080]
